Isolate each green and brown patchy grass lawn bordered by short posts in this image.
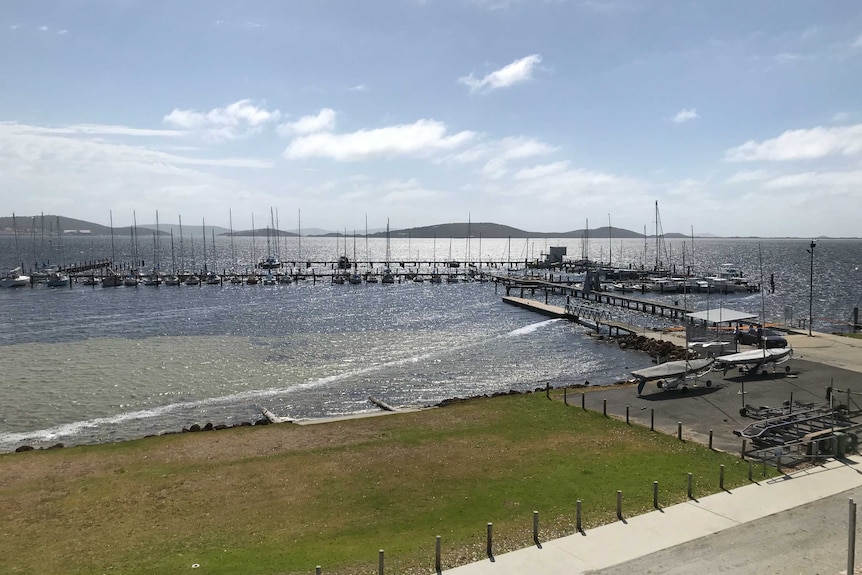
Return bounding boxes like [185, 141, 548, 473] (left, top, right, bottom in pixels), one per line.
[0, 393, 768, 575]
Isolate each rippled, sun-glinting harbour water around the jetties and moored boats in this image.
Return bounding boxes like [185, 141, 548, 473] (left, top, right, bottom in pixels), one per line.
[0, 237, 862, 451]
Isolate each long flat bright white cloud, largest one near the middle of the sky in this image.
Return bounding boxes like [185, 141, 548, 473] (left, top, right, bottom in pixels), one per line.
[284, 120, 475, 161]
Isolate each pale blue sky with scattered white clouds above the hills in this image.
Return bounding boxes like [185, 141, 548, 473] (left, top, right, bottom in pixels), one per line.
[0, 0, 862, 237]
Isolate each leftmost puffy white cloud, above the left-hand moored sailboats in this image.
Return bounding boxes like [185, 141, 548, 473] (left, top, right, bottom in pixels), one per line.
[162, 99, 281, 141]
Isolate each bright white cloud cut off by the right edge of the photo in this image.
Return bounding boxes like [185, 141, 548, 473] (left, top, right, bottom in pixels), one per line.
[724, 124, 862, 162]
